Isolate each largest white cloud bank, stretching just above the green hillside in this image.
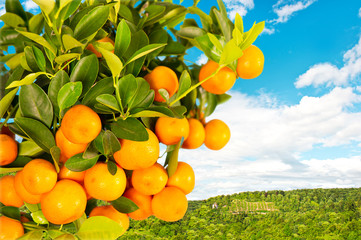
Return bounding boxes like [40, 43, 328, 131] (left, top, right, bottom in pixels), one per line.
[184, 87, 361, 199]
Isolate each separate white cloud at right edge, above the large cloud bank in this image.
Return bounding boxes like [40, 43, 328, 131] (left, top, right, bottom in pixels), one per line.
[295, 37, 361, 88]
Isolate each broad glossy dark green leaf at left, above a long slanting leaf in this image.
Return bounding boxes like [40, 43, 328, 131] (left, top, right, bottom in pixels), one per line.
[19, 83, 53, 128]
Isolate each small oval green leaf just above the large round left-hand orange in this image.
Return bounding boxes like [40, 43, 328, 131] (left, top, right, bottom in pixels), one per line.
[58, 82, 83, 111]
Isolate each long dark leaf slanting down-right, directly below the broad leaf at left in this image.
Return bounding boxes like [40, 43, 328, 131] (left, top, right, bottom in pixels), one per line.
[14, 117, 55, 153]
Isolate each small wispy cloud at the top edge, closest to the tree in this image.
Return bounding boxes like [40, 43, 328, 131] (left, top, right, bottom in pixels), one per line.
[272, 0, 316, 23]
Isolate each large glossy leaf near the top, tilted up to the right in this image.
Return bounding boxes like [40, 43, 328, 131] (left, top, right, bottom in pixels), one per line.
[74, 6, 109, 40]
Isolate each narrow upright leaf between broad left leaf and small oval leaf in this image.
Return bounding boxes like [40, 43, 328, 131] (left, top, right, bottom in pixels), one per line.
[48, 70, 70, 116]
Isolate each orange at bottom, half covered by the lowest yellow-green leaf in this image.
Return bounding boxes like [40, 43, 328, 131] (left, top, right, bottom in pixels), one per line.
[89, 205, 129, 235]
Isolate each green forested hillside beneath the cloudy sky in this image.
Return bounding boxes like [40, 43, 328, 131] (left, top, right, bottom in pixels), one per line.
[122, 188, 361, 240]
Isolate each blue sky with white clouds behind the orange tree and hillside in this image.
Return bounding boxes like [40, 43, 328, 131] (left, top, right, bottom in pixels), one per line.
[0, 0, 361, 199]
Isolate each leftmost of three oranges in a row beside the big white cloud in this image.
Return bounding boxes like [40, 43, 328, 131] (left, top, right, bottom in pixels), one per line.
[155, 117, 189, 145]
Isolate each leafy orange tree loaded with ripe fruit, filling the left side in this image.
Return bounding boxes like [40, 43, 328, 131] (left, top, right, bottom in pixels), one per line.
[0, 0, 264, 239]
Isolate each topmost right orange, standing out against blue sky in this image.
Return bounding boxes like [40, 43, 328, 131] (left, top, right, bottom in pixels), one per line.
[237, 45, 264, 79]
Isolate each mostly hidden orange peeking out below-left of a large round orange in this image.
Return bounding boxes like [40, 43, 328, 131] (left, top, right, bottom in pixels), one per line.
[55, 128, 88, 162]
